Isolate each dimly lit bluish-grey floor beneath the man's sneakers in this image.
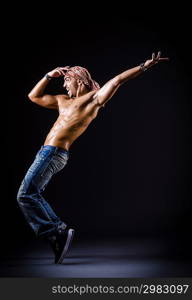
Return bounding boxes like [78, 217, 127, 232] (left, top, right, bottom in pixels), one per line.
[0, 237, 192, 278]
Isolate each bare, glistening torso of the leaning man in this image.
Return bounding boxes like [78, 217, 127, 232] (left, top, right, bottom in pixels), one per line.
[44, 92, 100, 150]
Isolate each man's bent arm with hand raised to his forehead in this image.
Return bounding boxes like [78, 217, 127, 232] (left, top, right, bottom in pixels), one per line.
[28, 68, 66, 109]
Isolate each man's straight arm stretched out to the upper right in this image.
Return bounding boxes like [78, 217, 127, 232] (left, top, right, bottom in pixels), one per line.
[94, 52, 169, 106]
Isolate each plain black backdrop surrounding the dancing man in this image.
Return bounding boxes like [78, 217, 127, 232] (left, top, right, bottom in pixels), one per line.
[0, 7, 192, 257]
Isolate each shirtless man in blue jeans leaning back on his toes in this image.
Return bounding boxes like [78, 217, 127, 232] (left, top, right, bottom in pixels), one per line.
[17, 52, 168, 264]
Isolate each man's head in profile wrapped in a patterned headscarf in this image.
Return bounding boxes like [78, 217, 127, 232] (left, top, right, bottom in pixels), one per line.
[62, 66, 100, 97]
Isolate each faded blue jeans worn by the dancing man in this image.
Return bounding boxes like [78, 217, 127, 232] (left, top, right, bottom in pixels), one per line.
[17, 145, 69, 238]
